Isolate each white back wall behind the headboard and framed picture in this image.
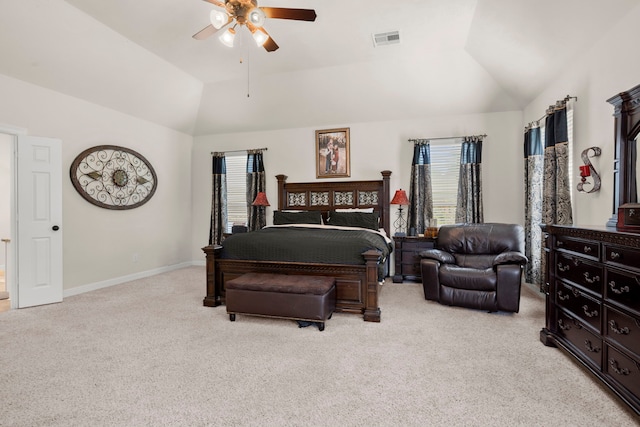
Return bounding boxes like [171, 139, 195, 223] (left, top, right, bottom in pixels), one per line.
[192, 111, 524, 260]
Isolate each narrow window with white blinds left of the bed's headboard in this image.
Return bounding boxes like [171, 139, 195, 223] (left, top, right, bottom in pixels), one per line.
[226, 153, 248, 233]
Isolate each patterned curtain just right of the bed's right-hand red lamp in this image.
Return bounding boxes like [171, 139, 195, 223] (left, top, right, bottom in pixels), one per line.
[402, 139, 433, 234]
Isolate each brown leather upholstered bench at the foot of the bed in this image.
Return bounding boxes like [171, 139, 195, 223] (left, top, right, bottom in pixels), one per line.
[225, 273, 336, 331]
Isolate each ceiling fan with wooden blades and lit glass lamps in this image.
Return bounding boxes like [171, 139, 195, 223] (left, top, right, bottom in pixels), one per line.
[193, 0, 316, 52]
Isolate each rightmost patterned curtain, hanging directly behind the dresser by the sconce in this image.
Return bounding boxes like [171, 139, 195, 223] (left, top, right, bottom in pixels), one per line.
[542, 101, 573, 225]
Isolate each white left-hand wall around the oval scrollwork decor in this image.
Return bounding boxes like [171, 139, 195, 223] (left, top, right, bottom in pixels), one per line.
[0, 75, 192, 290]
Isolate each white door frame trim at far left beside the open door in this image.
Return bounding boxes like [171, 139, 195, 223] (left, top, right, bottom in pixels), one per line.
[0, 123, 27, 309]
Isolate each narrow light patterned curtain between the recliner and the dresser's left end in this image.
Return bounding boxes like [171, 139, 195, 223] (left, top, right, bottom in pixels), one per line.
[524, 123, 544, 285]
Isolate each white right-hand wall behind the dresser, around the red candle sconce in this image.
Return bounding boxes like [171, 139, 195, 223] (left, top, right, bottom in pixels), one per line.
[524, 8, 640, 226]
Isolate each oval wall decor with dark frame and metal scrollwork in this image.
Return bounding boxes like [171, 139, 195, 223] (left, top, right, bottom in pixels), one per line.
[70, 145, 158, 210]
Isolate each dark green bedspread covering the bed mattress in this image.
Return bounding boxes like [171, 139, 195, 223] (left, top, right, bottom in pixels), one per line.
[220, 226, 392, 265]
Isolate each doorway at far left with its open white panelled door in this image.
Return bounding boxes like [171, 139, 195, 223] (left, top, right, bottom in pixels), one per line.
[0, 125, 63, 309]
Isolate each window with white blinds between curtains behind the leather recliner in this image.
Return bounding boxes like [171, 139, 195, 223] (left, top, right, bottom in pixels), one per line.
[430, 140, 460, 225]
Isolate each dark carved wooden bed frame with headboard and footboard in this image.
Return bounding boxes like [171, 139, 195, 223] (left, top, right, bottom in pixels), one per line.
[202, 171, 391, 322]
